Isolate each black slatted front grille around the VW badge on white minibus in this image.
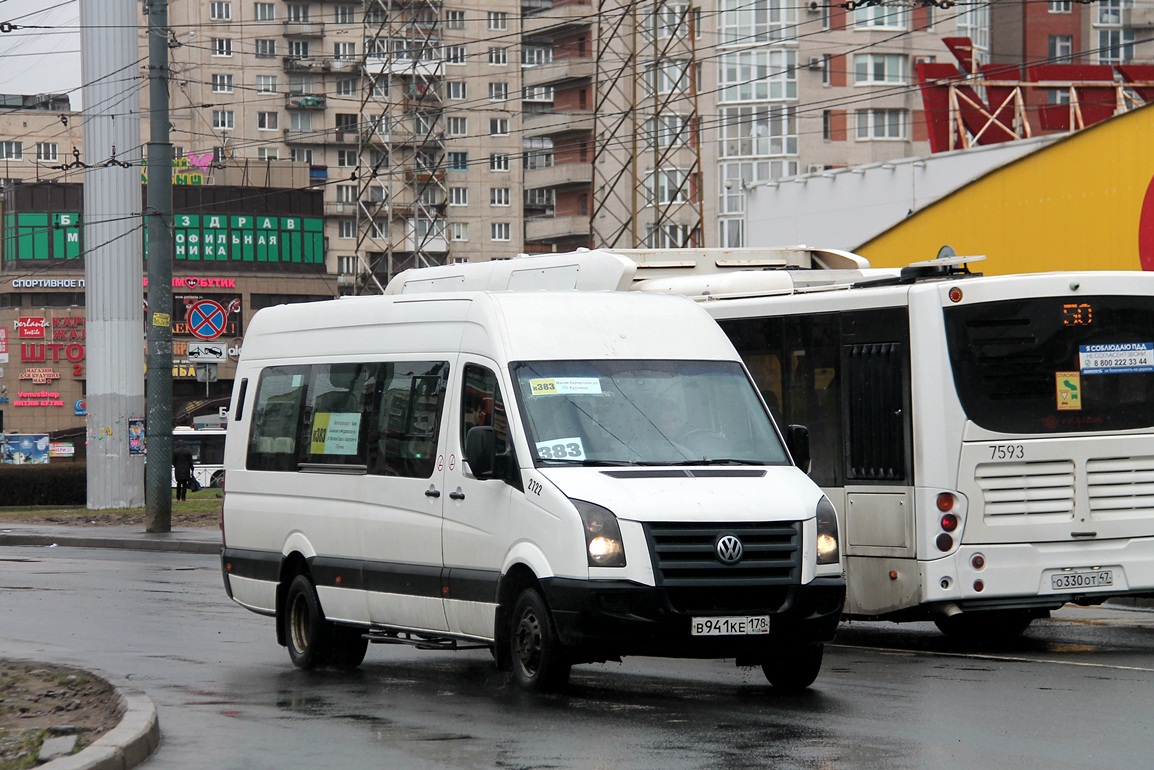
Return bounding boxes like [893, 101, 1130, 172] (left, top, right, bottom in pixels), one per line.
[645, 522, 801, 608]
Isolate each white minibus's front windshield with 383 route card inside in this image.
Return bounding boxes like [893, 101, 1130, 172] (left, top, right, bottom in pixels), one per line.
[511, 360, 788, 468]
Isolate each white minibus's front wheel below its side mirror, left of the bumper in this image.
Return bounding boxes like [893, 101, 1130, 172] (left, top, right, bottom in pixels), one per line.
[509, 588, 572, 693]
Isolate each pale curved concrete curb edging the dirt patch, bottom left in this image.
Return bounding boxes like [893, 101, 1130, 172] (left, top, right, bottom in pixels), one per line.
[38, 670, 160, 770]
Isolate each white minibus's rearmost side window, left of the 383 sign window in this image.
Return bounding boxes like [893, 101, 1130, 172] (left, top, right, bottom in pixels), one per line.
[245, 366, 309, 471]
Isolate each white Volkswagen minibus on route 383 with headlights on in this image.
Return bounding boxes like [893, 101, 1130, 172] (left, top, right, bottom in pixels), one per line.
[222, 277, 845, 690]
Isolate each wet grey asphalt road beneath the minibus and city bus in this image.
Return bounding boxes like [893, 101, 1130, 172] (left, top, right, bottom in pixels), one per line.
[0, 547, 1154, 770]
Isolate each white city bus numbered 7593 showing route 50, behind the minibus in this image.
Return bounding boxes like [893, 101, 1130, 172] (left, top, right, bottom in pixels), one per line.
[480, 247, 1154, 638]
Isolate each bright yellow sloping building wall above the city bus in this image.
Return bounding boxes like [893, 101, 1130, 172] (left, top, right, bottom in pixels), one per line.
[854, 105, 1154, 275]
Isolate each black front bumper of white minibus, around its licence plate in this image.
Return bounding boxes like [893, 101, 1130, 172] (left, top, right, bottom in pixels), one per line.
[542, 576, 846, 659]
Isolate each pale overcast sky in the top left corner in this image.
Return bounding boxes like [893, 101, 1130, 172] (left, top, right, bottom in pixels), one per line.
[0, 0, 83, 110]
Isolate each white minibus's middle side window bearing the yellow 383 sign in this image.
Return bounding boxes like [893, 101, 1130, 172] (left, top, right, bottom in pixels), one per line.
[304, 364, 380, 470]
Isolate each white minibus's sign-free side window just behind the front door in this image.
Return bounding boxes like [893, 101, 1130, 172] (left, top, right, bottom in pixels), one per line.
[368, 361, 449, 479]
